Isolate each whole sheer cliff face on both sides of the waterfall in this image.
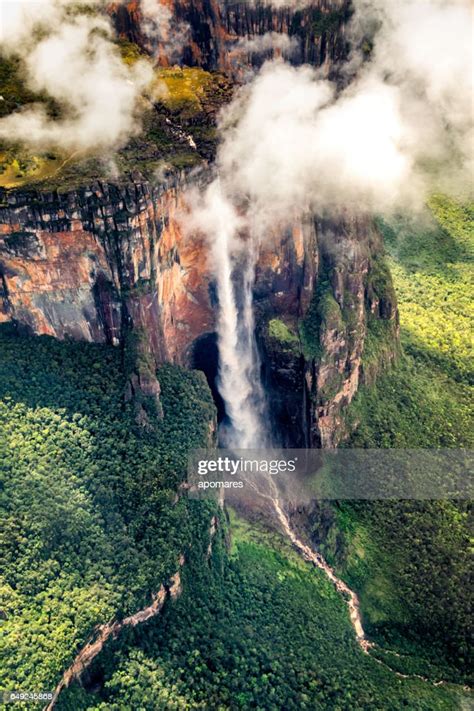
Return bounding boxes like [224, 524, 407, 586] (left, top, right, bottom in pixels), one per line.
[0, 177, 396, 446]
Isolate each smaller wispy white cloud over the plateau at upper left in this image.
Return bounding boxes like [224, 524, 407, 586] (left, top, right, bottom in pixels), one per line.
[0, 0, 153, 150]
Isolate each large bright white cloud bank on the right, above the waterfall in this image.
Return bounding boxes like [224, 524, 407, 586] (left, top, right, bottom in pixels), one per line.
[209, 0, 474, 225]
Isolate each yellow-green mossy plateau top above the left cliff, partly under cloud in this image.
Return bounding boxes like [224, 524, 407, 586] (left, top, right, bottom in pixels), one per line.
[0, 51, 232, 191]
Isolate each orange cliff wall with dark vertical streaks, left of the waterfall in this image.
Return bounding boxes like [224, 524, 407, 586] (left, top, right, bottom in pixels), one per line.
[0, 183, 213, 362]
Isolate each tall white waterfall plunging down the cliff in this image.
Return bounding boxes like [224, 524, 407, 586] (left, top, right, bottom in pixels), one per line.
[208, 181, 269, 449]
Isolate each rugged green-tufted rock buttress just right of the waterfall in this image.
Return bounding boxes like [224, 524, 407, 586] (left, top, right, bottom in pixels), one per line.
[256, 215, 398, 447]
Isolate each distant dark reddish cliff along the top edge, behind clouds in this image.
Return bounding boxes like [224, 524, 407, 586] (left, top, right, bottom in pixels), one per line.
[109, 0, 350, 77]
